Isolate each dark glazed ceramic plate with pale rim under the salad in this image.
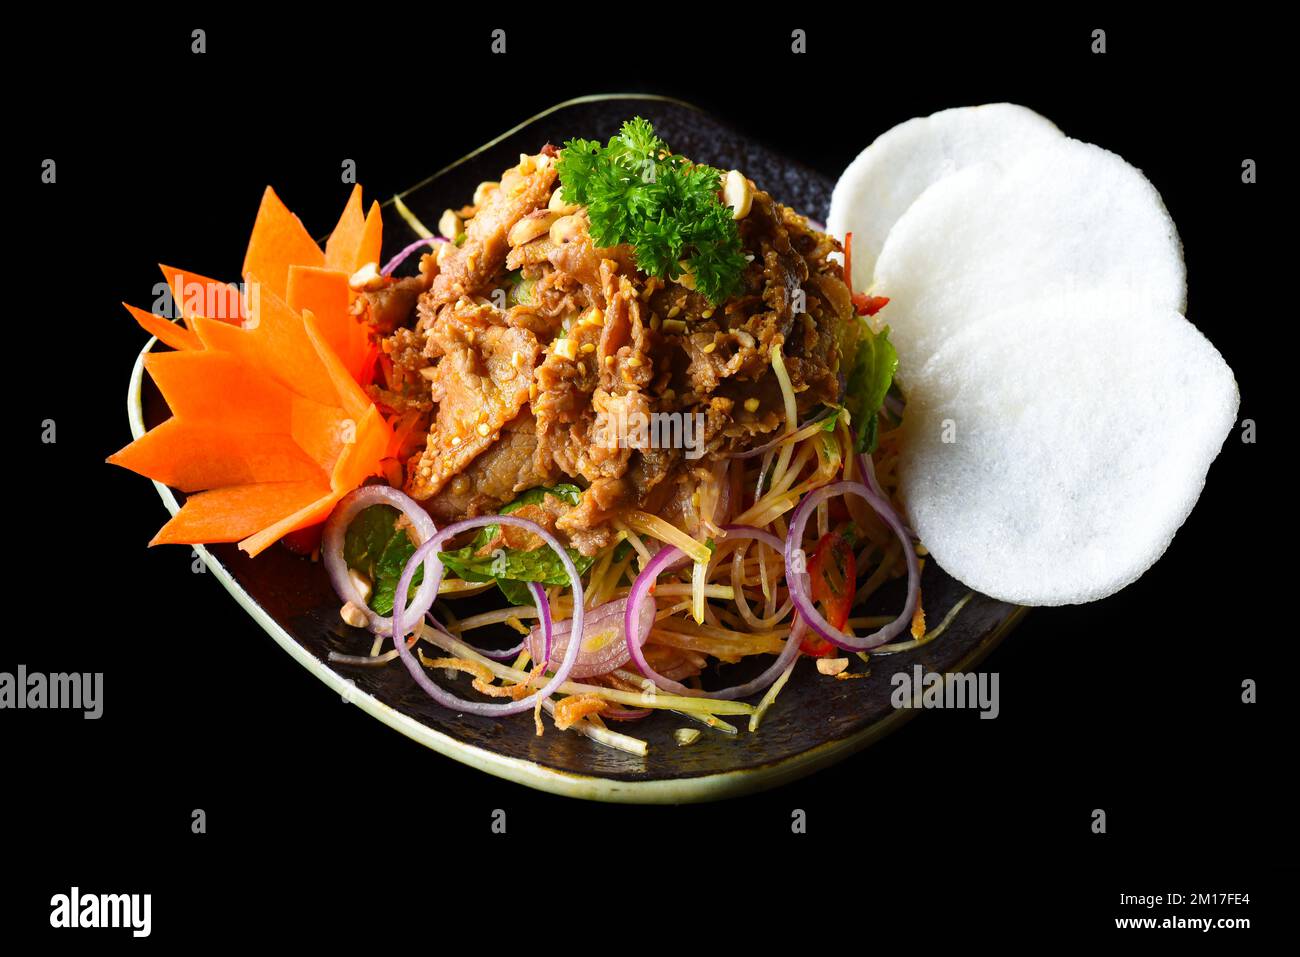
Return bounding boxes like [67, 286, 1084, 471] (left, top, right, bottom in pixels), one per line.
[129, 95, 1023, 802]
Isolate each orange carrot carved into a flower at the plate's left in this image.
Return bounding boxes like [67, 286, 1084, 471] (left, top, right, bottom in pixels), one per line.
[108, 186, 393, 555]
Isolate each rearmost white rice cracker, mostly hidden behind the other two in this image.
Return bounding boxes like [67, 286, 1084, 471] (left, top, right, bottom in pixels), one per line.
[827, 103, 1061, 291]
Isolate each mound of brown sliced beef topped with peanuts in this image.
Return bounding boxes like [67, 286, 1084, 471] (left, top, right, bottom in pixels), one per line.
[384, 150, 857, 554]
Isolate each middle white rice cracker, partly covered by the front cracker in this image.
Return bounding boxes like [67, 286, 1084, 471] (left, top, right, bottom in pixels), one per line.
[873, 137, 1187, 390]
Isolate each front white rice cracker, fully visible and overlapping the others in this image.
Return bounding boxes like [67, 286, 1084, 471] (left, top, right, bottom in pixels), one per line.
[898, 291, 1238, 605]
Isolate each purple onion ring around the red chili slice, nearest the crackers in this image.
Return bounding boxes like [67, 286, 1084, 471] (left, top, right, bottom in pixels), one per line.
[785, 481, 920, 651]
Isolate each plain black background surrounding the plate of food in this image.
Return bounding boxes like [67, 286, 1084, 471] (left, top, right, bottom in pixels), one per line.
[0, 5, 1295, 943]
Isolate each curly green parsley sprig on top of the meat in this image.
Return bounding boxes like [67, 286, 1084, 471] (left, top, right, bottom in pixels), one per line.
[559, 117, 746, 304]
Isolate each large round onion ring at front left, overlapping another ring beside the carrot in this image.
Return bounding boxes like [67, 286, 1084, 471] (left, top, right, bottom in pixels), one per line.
[393, 515, 582, 718]
